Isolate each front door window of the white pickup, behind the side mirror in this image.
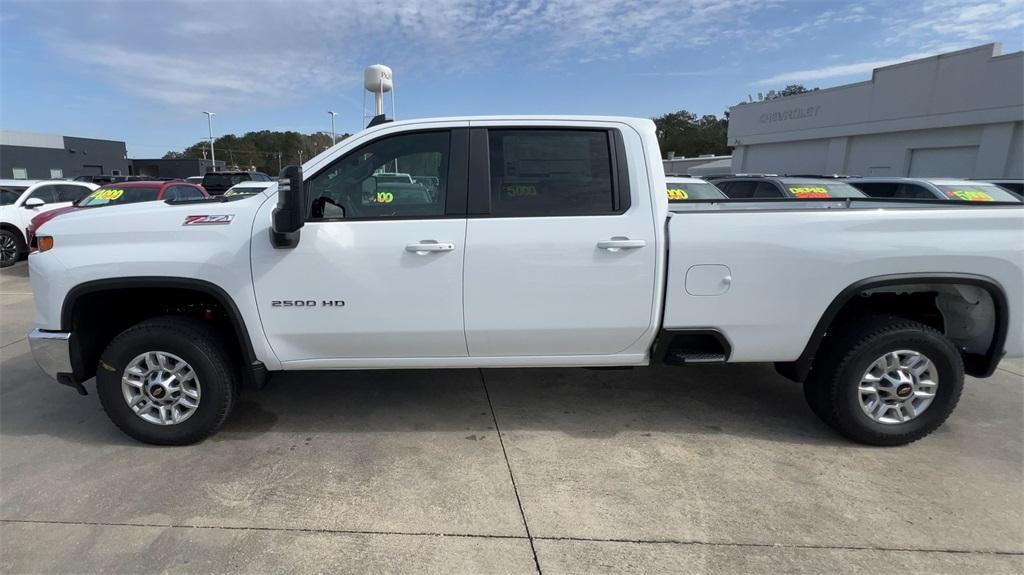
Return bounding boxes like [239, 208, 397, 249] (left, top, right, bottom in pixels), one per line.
[307, 131, 451, 221]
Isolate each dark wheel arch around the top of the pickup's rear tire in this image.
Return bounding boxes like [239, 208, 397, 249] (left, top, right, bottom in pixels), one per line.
[775, 273, 1010, 382]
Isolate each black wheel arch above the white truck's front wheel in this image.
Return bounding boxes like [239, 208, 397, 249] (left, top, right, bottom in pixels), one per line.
[60, 276, 266, 387]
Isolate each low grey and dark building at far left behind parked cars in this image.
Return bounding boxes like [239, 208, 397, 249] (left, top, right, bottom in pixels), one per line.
[0, 130, 131, 180]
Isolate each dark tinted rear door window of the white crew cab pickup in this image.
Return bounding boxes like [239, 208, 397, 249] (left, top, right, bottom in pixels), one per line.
[488, 129, 617, 217]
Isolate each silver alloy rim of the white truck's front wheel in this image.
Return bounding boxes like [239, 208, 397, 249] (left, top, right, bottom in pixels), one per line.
[121, 351, 201, 426]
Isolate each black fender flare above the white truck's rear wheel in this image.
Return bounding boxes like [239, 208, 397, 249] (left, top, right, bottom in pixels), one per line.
[775, 273, 1010, 382]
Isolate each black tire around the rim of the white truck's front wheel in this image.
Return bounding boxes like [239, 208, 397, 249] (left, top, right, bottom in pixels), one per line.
[96, 316, 238, 445]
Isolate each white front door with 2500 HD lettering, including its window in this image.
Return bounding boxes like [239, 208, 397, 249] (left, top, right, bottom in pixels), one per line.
[252, 130, 467, 360]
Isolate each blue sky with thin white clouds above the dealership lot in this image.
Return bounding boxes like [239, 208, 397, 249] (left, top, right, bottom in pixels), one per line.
[0, 0, 1024, 158]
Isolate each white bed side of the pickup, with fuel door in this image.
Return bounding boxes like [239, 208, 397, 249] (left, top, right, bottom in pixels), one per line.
[664, 200, 1024, 361]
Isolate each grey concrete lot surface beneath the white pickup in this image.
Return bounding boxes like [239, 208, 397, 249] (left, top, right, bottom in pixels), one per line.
[0, 263, 1024, 573]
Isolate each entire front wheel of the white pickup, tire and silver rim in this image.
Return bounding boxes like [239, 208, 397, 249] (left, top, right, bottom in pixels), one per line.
[96, 316, 238, 445]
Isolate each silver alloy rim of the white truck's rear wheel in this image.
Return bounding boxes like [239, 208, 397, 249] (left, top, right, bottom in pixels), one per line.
[858, 350, 939, 424]
